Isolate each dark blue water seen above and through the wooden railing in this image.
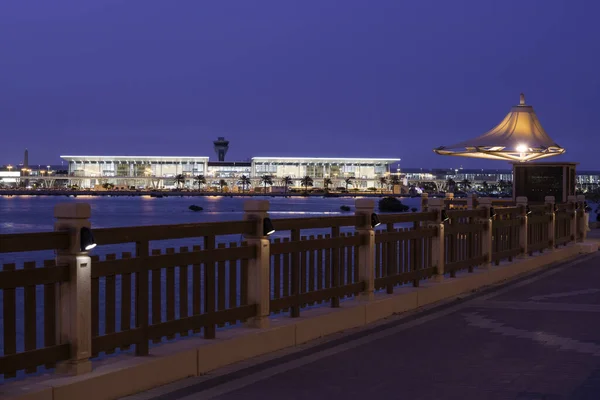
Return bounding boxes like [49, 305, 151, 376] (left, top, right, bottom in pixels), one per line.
[0, 196, 420, 382]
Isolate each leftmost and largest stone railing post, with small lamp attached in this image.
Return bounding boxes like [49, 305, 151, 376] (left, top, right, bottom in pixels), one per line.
[54, 203, 92, 375]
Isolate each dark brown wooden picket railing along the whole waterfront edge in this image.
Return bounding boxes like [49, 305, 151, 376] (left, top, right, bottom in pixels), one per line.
[0, 195, 585, 378]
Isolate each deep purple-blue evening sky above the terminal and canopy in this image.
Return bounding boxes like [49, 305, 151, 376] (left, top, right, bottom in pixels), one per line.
[0, 0, 600, 169]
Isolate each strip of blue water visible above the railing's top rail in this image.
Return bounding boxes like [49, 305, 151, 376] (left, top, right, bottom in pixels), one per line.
[0, 196, 420, 233]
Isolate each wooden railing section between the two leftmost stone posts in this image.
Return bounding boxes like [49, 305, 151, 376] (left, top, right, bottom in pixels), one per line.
[91, 221, 256, 356]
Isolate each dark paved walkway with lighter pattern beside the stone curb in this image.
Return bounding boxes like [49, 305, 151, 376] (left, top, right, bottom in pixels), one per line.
[128, 252, 600, 400]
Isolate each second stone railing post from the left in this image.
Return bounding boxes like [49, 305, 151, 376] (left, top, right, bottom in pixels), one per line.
[244, 200, 271, 328]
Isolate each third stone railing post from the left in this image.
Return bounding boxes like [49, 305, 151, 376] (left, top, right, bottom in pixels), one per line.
[354, 199, 375, 300]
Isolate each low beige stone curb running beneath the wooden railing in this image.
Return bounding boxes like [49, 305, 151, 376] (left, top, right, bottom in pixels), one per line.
[0, 242, 598, 400]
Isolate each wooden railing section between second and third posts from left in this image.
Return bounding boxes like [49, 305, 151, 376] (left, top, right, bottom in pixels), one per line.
[270, 216, 364, 317]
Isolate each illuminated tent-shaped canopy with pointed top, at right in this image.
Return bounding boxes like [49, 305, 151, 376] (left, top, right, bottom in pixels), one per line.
[433, 93, 565, 161]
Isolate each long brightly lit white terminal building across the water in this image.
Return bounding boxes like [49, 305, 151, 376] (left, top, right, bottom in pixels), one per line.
[61, 155, 400, 189]
